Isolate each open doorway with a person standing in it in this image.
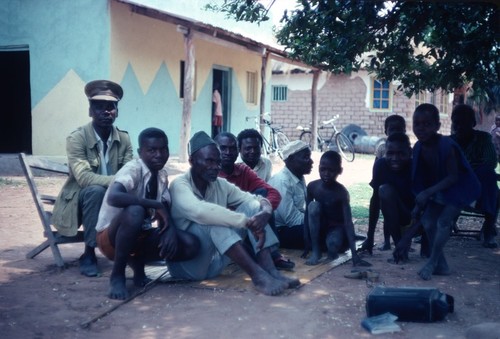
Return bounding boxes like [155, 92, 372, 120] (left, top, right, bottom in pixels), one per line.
[211, 67, 231, 138]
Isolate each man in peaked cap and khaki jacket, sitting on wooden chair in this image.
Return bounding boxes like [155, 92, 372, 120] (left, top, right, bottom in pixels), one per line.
[52, 80, 133, 277]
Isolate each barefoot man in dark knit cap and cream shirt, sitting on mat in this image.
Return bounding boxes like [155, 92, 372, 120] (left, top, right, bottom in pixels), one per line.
[169, 132, 300, 295]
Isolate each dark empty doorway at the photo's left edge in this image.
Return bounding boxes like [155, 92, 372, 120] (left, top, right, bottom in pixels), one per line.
[0, 47, 32, 154]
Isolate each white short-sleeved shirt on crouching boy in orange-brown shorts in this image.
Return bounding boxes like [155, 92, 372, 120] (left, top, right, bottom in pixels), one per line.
[96, 159, 171, 232]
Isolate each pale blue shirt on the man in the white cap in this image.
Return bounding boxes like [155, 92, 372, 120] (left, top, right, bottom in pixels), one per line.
[269, 167, 306, 227]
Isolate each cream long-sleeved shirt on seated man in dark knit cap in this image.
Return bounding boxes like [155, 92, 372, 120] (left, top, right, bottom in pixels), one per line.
[170, 170, 264, 230]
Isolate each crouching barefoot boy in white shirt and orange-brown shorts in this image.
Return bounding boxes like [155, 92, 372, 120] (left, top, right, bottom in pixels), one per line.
[96, 128, 200, 299]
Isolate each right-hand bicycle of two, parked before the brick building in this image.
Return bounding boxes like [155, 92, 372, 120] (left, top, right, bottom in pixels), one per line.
[297, 114, 355, 162]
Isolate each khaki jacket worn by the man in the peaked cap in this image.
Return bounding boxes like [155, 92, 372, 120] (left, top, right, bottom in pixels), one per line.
[52, 122, 133, 236]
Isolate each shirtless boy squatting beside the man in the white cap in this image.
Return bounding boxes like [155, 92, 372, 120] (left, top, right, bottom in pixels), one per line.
[305, 151, 371, 266]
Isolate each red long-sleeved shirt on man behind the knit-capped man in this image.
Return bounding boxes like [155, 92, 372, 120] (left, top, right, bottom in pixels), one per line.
[219, 164, 281, 210]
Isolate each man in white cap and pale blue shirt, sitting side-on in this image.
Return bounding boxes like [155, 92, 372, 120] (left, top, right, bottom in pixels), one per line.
[269, 140, 313, 255]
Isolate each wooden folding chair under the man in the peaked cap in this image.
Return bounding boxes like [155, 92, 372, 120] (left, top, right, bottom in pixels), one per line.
[19, 153, 84, 267]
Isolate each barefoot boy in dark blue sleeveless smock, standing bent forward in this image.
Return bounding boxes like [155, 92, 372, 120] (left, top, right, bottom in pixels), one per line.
[412, 104, 481, 280]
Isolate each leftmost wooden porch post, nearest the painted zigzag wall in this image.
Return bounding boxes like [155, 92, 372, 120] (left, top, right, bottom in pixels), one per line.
[179, 29, 195, 162]
